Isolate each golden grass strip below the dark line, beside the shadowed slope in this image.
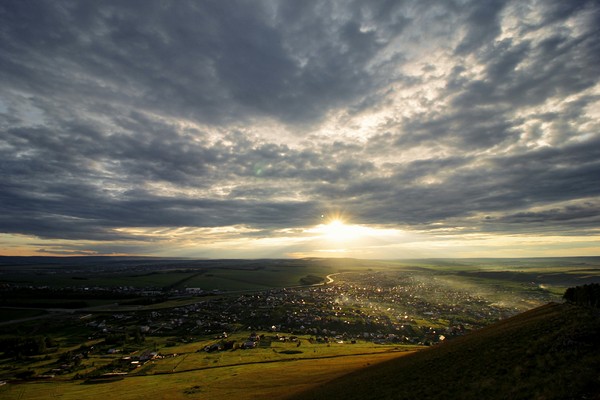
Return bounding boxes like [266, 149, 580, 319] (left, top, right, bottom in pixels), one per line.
[0, 351, 410, 400]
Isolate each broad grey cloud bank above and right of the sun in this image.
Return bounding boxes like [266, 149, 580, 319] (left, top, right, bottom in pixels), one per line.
[308, 135, 600, 231]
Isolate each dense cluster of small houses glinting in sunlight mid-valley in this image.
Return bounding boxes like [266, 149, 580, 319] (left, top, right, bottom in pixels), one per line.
[77, 272, 528, 343]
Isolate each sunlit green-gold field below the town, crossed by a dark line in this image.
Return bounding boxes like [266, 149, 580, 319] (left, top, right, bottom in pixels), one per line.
[0, 337, 417, 399]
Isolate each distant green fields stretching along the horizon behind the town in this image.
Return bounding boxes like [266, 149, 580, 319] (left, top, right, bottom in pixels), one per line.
[0, 257, 600, 292]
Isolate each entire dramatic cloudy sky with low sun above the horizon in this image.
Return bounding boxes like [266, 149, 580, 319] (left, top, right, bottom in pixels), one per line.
[0, 0, 600, 258]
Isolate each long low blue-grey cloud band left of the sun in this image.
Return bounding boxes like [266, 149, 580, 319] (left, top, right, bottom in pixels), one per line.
[0, 178, 320, 240]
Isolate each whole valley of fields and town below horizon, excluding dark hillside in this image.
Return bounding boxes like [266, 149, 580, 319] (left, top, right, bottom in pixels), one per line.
[0, 258, 600, 399]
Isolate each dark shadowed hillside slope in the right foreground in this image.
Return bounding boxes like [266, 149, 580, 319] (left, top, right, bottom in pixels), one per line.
[293, 304, 600, 400]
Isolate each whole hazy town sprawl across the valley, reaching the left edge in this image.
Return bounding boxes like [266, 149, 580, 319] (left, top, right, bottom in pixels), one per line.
[3, 271, 556, 344]
